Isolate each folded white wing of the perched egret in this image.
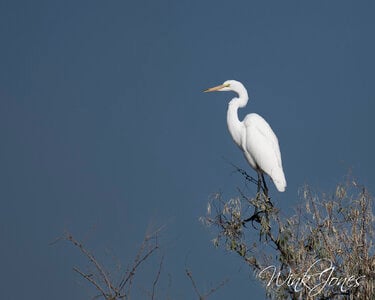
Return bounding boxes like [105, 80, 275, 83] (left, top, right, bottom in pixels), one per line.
[243, 114, 286, 191]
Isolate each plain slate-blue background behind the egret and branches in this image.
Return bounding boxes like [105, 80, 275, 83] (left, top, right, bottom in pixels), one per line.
[0, 1, 375, 300]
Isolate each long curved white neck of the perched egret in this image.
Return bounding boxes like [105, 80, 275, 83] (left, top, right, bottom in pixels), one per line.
[227, 90, 249, 148]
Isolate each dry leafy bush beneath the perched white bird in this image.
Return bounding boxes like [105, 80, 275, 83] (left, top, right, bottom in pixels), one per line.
[202, 176, 375, 299]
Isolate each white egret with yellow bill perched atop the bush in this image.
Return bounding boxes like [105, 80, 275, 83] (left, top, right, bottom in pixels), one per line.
[204, 80, 286, 193]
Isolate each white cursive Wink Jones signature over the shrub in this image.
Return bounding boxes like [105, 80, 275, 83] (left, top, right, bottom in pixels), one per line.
[258, 259, 366, 296]
